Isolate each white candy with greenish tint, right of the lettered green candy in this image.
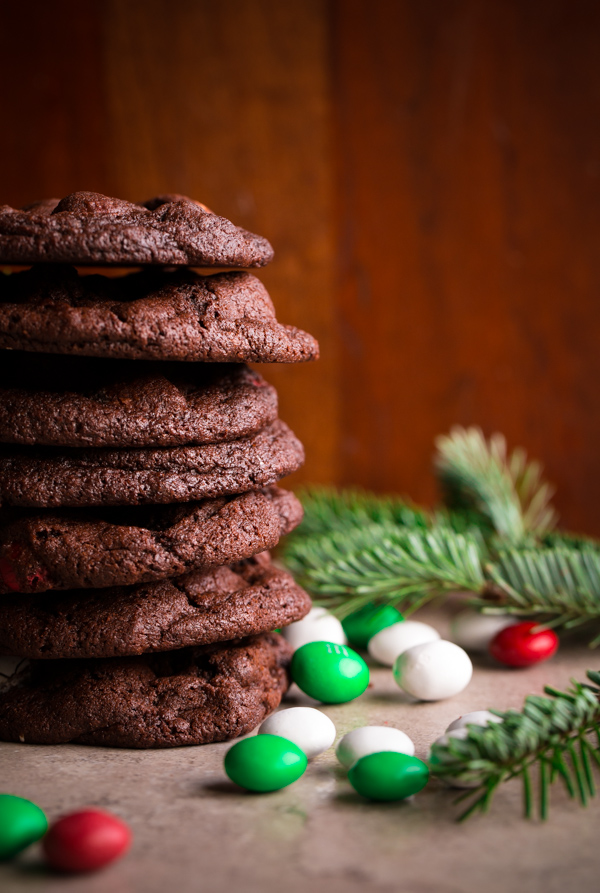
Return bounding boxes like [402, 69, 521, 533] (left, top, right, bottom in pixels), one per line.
[394, 639, 473, 701]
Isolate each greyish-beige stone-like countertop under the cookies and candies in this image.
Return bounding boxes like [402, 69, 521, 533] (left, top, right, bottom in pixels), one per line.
[0, 614, 600, 893]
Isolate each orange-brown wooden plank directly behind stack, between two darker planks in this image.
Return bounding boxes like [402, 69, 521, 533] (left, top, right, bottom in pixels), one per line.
[105, 0, 339, 483]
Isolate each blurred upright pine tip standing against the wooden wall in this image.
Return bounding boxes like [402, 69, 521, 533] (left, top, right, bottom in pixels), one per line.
[434, 427, 556, 544]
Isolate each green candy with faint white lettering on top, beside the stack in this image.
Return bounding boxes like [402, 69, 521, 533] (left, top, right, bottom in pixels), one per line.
[291, 642, 369, 704]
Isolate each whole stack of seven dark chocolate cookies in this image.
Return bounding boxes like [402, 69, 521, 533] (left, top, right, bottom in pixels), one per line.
[0, 192, 318, 747]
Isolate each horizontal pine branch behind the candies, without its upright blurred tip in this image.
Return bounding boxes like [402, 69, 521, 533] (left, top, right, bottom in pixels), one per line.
[284, 493, 600, 645]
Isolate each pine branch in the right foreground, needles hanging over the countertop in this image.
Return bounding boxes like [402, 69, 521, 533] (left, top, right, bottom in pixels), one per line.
[429, 671, 600, 820]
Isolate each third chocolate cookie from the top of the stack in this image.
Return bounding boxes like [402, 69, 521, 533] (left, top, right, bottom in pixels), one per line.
[0, 350, 277, 447]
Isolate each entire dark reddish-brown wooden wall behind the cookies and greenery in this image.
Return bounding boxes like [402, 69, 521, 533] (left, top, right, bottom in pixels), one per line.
[0, 0, 600, 534]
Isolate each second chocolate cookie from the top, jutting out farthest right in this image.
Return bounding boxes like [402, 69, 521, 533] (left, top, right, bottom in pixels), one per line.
[0, 266, 319, 363]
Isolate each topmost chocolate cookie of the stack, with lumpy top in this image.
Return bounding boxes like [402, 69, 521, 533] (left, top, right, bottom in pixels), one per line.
[0, 192, 273, 267]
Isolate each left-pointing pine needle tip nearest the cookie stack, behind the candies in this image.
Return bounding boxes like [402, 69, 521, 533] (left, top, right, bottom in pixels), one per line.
[284, 522, 485, 616]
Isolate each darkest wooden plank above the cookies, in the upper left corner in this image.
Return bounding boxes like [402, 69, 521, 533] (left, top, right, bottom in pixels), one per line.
[0, 0, 106, 207]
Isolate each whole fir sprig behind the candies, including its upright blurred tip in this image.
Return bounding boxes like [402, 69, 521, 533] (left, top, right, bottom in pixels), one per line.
[283, 428, 600, 644]
